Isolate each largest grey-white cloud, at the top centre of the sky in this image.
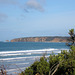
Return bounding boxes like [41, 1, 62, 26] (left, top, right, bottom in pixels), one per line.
[26, 0, 44, 12]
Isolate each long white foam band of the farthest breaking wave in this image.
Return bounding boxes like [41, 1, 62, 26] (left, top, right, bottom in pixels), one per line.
[0, 49, 58, 57]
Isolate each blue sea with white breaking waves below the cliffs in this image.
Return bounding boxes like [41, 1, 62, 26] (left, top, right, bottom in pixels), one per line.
[0, 42, 69, 75]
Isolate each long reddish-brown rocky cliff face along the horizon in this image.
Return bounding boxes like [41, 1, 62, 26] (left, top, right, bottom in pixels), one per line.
[11, 37, 69, 42]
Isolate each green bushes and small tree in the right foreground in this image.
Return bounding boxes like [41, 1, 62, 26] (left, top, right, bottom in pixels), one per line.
[20, 29, 75, 75]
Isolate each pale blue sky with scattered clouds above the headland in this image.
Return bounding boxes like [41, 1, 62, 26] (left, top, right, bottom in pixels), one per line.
[0, 0, 75, 41]
